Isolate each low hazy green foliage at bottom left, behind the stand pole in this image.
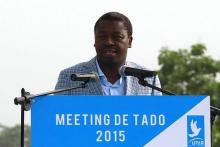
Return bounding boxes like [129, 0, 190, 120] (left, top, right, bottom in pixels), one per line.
[0, 125, 30, 147]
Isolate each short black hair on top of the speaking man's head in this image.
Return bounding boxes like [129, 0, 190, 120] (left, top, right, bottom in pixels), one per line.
[94, 12, 132, 36]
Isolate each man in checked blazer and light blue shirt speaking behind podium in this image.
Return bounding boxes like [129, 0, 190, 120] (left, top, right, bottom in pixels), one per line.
[55, 12, 161, 95]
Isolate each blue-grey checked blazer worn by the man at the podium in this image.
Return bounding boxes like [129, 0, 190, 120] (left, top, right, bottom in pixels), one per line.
[55, 57, 162, 95]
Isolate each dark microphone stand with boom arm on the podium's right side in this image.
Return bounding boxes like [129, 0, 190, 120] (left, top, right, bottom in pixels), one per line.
[138, 77, 220, 146]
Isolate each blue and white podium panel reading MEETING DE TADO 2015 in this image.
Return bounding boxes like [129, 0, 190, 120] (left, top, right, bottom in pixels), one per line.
[31, 96, 210, 147]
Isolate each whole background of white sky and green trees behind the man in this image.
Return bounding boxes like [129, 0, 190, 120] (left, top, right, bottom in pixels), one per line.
[0, 0, 220, 147]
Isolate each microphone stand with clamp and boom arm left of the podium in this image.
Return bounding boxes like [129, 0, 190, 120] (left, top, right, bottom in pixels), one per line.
[14, 80, 89, 147]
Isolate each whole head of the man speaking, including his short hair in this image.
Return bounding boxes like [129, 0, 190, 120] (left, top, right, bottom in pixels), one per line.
[94, 12, 132, 66]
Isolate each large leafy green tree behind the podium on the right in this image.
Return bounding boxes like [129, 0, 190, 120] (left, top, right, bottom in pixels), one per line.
[159, 44, 220, 147]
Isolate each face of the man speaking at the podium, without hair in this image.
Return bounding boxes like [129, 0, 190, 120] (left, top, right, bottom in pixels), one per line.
[94, 20, 132, 66]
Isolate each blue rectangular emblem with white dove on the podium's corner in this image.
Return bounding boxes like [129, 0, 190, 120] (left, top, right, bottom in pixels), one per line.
[187, 115, 205, 147]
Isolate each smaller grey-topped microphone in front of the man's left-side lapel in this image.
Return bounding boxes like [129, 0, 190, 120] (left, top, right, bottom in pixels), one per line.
[71, 72, 99, 82]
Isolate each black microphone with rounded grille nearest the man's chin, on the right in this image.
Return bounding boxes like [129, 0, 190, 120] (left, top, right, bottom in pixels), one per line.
[119, 65, 157, 79]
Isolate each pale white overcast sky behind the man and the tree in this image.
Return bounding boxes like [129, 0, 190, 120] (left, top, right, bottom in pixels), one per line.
[0, 0, 220, 126]
